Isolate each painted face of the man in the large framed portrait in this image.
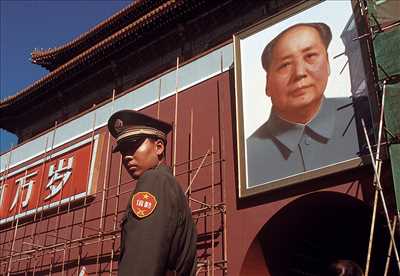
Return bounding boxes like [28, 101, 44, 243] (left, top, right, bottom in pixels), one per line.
[266, 26, 329, 122]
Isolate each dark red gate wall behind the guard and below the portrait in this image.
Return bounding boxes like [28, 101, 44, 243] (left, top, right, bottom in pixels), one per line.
[0, 72, 390, 275]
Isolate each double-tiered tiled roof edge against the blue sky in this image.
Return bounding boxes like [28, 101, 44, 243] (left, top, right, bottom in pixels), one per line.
[0, 0, 188, 109]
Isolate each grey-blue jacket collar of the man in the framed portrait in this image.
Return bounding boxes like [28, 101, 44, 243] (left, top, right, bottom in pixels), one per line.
[268, 98, 336, 152]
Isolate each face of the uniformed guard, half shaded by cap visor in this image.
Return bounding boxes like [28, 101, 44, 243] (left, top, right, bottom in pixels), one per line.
[120, 138, 164, 179]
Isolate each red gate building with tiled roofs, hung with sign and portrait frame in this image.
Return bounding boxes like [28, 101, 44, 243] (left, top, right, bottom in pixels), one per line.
[0, 0, 397, 275]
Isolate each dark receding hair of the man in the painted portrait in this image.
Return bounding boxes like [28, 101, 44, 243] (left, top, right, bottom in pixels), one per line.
[261, 23, 332, 72]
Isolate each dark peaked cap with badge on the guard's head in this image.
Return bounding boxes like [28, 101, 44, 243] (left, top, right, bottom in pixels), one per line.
[108, 110, 172, 152]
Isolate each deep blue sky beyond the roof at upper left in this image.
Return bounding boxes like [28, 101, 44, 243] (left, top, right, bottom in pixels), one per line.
[0, 0, 131, 152]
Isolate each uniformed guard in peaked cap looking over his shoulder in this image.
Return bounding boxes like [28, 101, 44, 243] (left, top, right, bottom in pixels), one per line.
[108, 110, 197, 276]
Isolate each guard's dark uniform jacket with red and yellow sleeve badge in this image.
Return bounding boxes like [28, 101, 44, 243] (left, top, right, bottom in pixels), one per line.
[118, 164, 197, 276]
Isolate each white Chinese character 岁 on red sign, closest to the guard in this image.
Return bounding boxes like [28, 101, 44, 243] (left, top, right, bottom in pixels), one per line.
[45, 157, 74, 200]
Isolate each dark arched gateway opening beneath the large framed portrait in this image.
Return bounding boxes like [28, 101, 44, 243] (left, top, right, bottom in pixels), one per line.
[240, 192, 397, 276]
